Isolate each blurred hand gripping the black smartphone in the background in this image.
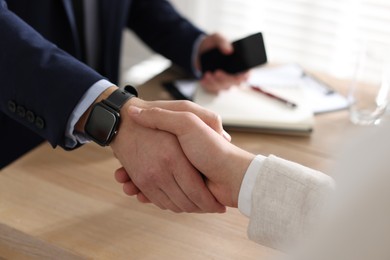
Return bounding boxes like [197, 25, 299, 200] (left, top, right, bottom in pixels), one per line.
[197, 33, 249, 93]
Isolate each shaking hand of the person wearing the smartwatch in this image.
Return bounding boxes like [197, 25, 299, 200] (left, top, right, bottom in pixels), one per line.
[111, 98, 228, 212]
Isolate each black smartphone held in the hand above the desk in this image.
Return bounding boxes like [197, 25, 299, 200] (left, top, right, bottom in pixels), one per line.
[200, 33, 267, 74]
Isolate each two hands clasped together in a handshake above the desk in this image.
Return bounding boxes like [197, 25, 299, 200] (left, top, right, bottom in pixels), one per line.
[111, 98, 255, 213]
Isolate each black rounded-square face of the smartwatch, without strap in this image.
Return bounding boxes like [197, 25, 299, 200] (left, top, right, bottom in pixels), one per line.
[85, 103, 119, 146]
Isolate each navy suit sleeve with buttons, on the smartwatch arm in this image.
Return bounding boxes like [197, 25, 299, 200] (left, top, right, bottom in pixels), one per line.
[0, 0, 103, 146]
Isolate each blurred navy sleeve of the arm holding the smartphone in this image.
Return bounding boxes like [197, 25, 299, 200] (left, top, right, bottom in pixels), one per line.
[128, 0, 203, 75]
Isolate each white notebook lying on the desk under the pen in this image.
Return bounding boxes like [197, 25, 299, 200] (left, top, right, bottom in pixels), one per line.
[193, 86, 314, 134]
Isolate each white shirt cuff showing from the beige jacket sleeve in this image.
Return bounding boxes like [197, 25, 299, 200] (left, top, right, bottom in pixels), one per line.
[238, 155, 266, 217]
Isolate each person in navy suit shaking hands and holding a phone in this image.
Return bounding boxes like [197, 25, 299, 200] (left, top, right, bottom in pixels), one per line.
[0, 0, 250, 212]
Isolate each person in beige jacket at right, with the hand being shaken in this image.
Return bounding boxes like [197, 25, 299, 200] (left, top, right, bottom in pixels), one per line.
[115, 107, 390, 260]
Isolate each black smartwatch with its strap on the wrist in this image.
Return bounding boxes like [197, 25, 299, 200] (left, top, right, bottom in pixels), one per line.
[84, 86, 138, 146]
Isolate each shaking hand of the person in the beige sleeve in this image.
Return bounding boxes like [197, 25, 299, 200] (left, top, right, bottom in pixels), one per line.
[119, 107, 254, 207]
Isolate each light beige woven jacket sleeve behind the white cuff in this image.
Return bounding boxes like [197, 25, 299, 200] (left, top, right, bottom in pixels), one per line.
[248, 156, 334, 251]
